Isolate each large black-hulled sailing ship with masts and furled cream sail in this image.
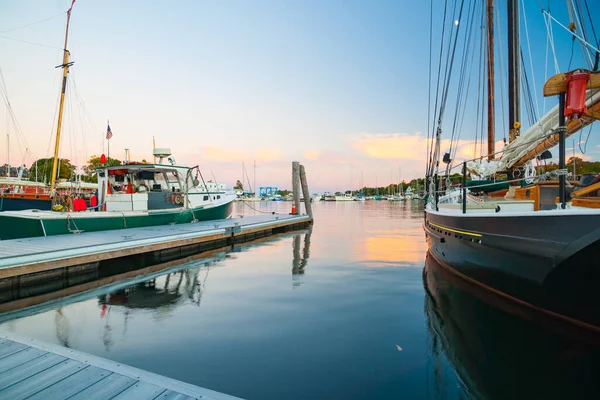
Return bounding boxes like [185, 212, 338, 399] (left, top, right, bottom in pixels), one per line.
[423, 0, 600, 313]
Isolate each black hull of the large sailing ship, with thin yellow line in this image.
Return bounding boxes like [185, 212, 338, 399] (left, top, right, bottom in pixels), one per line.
[424, 212, 600, 326]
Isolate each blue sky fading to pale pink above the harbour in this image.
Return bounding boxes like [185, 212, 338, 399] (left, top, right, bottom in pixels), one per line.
[0, 0, 600, 192]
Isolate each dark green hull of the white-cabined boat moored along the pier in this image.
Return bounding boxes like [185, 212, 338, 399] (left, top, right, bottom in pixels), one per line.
[0, 202, 233, 240]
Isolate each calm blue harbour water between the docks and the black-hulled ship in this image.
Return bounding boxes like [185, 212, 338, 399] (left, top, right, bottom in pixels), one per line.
[0, 201, 600, 399]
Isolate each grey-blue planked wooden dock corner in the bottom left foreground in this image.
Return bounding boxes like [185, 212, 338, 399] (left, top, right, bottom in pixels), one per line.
[0, 332, 237, 400]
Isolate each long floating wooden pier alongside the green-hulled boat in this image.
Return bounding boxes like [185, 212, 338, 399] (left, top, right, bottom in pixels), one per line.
[0, 214, 312, 280]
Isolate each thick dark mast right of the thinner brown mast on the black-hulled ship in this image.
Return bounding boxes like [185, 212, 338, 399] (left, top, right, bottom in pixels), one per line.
[507, 0, 521, 142]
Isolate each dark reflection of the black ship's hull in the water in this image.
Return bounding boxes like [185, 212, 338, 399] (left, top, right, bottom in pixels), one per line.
[423, 256, 600, 399]
